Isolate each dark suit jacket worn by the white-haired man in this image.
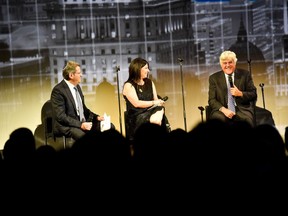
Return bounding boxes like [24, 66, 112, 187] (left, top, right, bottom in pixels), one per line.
[208, 69, 257, 120]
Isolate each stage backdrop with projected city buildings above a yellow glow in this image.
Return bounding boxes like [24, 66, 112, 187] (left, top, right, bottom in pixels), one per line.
[0, 0, 288, 149]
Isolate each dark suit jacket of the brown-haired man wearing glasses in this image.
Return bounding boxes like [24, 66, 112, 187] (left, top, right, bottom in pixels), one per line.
[51, 80, 98, 135]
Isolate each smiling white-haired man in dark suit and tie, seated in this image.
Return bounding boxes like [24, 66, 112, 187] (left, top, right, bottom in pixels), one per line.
[208, 51, 257, 126]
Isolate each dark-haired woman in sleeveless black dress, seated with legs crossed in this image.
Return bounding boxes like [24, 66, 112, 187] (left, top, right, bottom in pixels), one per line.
[123, 58, 168, 140]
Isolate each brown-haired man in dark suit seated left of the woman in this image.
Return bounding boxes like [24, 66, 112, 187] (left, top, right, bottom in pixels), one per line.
[51, 61, 115, 140]
